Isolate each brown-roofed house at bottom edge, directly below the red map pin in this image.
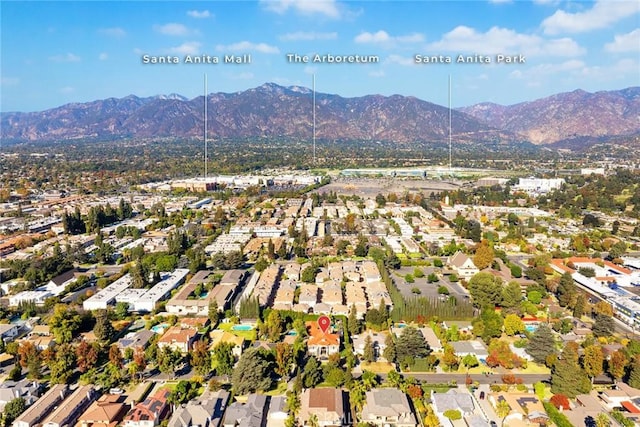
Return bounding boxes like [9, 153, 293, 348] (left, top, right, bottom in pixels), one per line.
[298, 388, 349, 427]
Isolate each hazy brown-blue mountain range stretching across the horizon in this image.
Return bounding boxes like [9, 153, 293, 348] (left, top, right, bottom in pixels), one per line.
[0, 83, 640, 148]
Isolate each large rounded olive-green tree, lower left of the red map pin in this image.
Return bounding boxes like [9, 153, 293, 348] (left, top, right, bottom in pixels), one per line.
[231, 348, 272, 395]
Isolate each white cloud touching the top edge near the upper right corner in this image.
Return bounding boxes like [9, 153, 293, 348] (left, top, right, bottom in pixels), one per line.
[542, 0, 640, 34]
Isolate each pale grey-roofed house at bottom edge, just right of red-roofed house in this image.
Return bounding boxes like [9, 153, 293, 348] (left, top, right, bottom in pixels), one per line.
[168, 390, 230, 427]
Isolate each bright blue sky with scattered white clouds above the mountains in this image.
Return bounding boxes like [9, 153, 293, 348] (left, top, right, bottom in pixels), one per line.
[0, 0, 640, 112]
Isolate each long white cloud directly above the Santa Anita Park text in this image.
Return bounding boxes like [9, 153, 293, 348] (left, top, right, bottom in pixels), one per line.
[428, 25, 586, 57]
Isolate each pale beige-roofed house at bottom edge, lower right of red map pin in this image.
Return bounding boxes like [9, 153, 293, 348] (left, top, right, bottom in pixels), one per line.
[361, 388, 418, 427]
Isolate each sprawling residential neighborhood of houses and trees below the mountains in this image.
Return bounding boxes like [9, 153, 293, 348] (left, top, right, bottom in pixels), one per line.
[0, 166, 640, 427]
